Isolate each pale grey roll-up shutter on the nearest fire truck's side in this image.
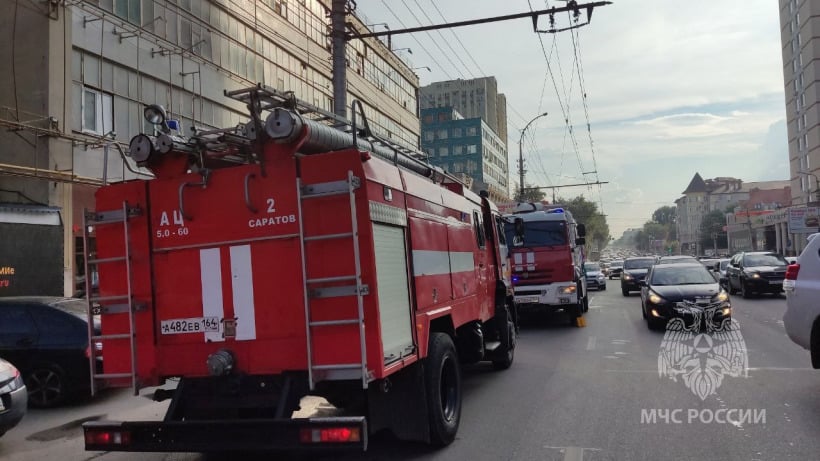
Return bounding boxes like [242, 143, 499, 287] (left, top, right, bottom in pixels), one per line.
[373, 224, 413, 363]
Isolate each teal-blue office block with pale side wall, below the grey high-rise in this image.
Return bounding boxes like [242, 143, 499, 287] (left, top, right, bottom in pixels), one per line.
[421, 106, 509, 203]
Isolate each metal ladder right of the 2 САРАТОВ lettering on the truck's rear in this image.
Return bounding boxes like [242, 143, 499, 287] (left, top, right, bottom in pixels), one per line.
[296, 171, 369, 390]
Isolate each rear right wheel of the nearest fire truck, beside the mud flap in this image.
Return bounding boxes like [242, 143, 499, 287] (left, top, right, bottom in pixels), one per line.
[424, 333, 461, 446]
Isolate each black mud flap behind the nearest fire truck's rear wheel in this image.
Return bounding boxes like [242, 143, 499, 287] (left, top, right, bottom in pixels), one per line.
[367, 362, 430, 443]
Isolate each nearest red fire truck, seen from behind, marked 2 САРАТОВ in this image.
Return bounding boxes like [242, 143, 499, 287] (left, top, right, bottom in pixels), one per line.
[83, 85, 516, 452]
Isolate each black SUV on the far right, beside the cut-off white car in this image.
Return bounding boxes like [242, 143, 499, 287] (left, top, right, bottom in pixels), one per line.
[726, 251, 789, 298]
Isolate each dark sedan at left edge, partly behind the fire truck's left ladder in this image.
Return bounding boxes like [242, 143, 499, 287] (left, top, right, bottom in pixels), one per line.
[0, 297, 101, 407]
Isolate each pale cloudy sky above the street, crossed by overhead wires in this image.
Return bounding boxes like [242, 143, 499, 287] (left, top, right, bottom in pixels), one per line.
[356, 0, 789, 238]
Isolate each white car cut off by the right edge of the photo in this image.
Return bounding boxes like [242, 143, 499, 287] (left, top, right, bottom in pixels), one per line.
[783, 234, 820, 369]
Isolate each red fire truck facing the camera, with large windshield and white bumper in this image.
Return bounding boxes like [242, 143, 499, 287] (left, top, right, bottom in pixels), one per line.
[504, 203, 589, 325]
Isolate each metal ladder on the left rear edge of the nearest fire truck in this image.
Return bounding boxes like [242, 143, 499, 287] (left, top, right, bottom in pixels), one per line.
[83, 202, 141, 396]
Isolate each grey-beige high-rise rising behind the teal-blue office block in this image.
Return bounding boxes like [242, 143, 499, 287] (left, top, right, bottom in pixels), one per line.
[419, 77, 507, 146]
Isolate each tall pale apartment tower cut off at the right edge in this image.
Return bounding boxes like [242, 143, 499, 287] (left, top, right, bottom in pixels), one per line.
[780, 0, 820, 205]
